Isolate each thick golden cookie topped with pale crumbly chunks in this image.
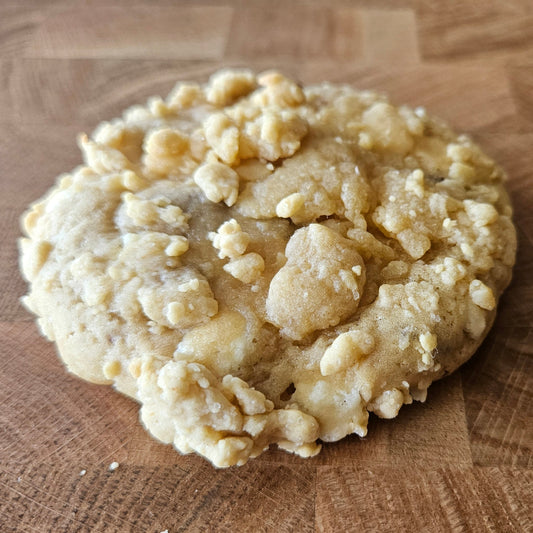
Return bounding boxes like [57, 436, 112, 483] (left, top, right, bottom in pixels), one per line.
[20, 70, 516, 466]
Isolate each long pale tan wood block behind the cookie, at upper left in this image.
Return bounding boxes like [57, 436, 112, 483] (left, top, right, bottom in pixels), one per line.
[24, 5, 233, 59]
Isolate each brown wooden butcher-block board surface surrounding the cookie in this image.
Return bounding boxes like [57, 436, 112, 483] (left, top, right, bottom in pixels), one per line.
[0, 0, 533, 533]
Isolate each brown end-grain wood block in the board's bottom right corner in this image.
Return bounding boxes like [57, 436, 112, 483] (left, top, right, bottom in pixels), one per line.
[316, 466, 533, 533]
